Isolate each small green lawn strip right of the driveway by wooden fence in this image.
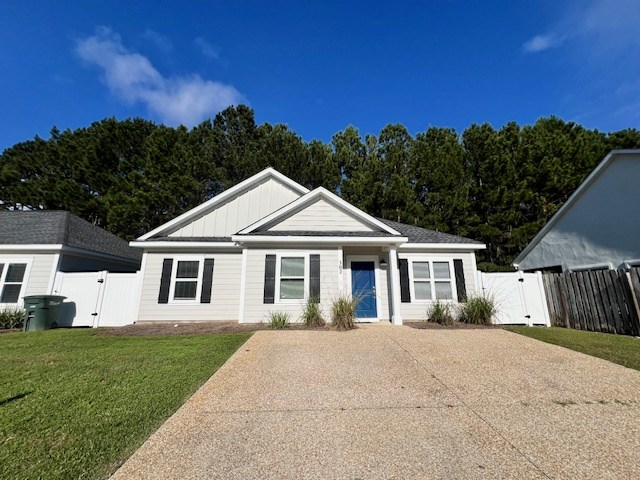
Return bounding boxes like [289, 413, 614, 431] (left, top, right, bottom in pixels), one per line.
[508, 327, 640, 370]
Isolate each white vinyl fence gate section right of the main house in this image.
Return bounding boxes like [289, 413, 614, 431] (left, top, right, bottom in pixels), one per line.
[478, 272, 550, 326]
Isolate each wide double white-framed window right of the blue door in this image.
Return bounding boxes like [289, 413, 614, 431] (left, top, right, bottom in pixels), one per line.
[409, 259, 457, 302]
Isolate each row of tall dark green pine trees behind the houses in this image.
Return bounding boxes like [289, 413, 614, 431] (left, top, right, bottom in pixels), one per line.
[0, 105, 640, 270]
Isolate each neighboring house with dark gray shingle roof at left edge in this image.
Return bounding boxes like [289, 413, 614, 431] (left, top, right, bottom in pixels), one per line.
[0, 210, 142, 307]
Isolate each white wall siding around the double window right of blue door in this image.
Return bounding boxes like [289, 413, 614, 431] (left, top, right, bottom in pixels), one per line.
[398, 251, 476, 321]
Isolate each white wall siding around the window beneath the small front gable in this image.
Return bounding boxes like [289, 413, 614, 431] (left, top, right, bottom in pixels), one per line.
[243, 248, 340, 323]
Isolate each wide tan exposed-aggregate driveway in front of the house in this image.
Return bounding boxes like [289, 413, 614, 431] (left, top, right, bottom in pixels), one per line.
[113, 325, 640, 480]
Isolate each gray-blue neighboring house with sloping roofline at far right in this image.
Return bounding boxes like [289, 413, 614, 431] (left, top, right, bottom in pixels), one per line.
[513, 150, 640, 272]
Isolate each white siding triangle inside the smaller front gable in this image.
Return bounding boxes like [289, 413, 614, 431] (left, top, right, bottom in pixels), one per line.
[269, 199, 373, 232]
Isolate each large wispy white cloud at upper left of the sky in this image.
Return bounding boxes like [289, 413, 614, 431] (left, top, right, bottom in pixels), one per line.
[76, 27, 245, 126]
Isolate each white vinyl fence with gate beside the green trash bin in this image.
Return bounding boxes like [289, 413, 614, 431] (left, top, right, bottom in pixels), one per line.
[53, 271, 140, 327]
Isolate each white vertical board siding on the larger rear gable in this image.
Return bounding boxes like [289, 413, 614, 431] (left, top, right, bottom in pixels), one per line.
[169, 178, 300, 237]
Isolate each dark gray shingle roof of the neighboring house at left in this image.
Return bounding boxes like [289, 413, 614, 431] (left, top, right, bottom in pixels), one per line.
[0, 210, 141, 261]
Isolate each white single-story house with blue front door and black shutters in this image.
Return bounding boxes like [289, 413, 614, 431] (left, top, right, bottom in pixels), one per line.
[131, 168, 485, 324]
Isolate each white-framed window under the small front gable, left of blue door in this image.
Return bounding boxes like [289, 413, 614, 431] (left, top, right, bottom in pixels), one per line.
[275, 252, 309, 303]
